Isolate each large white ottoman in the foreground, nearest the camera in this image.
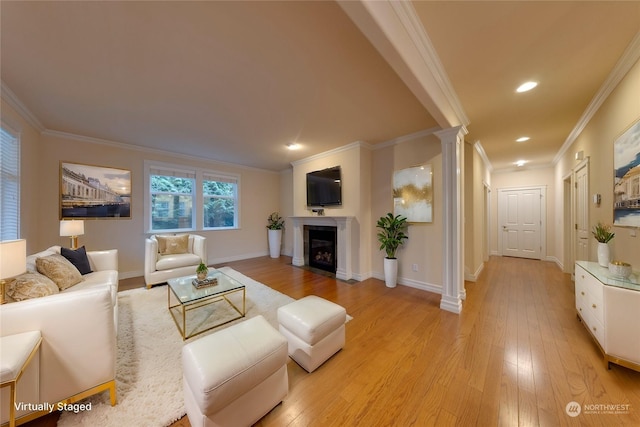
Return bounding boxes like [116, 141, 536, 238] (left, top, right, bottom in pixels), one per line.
[182, 316, 289, 427]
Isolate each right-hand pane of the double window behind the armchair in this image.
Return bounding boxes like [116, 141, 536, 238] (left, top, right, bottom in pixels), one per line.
[202, 174, 238, 228]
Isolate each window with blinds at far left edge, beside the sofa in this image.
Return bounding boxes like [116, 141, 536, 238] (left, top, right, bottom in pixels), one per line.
[0, 127, 20, 240]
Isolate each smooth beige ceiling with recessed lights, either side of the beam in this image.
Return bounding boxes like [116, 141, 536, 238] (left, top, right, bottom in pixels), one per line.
[0, 0, 640, 171]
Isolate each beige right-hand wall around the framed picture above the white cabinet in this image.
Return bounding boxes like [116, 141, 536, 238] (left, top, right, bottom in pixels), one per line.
[555, 57, 640, 270]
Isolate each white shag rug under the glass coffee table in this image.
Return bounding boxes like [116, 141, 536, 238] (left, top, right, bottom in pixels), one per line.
[58, 267, 294, 427]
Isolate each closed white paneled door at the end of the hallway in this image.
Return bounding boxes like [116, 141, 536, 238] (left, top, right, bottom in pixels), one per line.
[498, 187, 542, 259]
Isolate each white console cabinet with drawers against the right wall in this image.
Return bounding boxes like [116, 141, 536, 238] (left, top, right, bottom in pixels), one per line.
[575, 261, 640, 371]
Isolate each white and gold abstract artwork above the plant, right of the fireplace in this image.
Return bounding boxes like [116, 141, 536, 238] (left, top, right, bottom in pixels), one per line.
[393, 165, 433, 222]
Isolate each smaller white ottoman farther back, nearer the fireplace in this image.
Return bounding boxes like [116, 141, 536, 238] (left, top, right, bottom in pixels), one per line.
[278, 295, 347, 372]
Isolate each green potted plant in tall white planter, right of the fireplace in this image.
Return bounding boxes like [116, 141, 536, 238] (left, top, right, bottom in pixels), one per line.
[376, 212, 409, 288]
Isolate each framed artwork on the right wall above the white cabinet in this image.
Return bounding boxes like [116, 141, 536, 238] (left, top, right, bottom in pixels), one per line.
[613, 120, 640, 227]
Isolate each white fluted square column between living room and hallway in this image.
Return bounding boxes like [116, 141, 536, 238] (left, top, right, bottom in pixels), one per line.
[434, 126, 465, 314]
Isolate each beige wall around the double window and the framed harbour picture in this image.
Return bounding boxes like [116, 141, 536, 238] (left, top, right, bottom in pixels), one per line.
[9, 110, 281, 278]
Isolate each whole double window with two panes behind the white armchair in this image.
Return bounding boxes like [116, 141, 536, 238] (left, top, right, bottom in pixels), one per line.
[145, 162, 239, 232]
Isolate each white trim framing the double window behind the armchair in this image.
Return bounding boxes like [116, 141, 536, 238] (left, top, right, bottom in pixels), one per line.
[144, 160, 242, 234]
